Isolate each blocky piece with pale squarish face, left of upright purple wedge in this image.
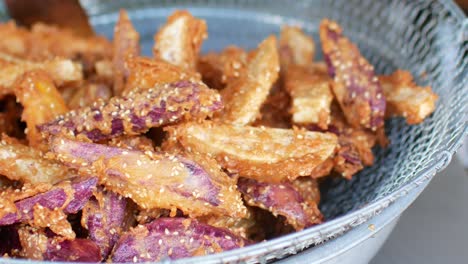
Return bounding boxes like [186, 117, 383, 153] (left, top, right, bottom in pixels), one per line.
[284, 65, 333, 129]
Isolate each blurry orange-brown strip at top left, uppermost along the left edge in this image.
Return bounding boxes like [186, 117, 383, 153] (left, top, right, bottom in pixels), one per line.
[0, 22, 112, 64]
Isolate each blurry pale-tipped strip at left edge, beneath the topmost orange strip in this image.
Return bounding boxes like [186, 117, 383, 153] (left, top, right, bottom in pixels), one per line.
[0, 55, 83, 98]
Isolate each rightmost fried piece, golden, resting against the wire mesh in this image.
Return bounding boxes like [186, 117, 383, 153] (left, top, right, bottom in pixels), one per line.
[379, 70, 438, 125]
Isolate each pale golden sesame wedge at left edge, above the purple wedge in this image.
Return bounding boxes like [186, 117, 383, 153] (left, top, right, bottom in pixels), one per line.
[0, 135, 69, 184]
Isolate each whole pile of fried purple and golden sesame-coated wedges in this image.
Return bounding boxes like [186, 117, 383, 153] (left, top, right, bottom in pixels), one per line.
[0, 8, 437, 262]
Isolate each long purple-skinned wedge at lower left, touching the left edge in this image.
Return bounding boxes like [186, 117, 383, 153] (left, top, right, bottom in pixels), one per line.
[0, 177, 97, 226]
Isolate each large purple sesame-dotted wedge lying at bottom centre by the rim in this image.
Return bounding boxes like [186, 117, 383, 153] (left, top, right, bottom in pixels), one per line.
[111, 218, 248, 263]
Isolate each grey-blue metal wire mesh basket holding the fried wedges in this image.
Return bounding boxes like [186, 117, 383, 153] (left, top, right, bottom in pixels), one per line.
[1, 0, 468, 263]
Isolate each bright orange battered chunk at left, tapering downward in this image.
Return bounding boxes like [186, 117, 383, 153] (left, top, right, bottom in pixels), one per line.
[15, 70, 68, 147]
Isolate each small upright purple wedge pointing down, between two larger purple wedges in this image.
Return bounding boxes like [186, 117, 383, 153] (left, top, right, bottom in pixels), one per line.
[81, 190, 127, 259]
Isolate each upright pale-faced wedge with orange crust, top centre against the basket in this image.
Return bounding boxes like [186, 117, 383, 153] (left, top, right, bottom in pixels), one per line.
[153, 11, 208, 71]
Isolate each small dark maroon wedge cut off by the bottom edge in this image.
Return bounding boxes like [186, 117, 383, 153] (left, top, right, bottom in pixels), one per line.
[43, 238, 101, 263]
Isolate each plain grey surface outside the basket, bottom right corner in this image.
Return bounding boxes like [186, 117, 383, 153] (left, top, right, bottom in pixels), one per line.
[370, 158, 468, 264]
